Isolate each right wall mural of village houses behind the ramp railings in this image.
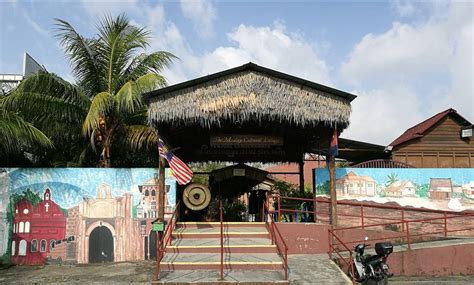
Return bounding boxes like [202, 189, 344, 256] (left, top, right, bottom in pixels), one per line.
[313, 168, 474, 211]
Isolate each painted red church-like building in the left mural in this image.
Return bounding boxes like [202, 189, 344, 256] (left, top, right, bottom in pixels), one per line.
[11, 189, 66, 264]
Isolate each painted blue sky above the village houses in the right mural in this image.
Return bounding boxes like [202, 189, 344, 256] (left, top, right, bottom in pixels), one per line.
[313, 168, 474, 185]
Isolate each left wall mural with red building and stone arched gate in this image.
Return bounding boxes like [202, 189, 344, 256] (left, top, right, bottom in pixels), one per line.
[0, 168, 176, 264]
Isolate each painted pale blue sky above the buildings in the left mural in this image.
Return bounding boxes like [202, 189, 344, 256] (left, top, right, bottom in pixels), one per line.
[0, 168, 176, 209]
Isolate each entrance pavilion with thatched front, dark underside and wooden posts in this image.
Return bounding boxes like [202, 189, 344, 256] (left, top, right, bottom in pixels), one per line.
[144, 63, 356, 225]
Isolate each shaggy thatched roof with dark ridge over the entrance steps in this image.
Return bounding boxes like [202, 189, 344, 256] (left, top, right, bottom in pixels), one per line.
[145, 63, 356, 130]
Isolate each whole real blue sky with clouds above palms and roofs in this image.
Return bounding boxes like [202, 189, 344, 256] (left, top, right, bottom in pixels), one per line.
[0, 0, 474, 145]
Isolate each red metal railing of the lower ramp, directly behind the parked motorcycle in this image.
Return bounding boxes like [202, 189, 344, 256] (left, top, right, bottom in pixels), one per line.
[328, 213, 474, 284]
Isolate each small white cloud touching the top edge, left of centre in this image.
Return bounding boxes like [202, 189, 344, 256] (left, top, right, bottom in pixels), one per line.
[181, 0, 217, 39]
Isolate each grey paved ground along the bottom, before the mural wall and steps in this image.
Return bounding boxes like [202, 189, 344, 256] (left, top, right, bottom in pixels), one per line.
[0, 255, 474, 285]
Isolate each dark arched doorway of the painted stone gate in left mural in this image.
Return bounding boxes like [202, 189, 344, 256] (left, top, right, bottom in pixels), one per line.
[89, 227, 114, 263]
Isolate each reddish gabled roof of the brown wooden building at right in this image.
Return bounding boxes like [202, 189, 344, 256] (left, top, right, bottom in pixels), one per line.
[389, 108, 471, 147]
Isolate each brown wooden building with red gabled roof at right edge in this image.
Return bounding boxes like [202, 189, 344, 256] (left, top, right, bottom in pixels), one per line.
[388, 109, 474, 168]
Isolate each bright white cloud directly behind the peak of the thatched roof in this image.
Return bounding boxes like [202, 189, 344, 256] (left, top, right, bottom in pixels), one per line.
[202, 23, 331, 85]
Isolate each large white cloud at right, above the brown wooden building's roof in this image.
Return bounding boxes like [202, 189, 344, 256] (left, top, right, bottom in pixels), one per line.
[340, 2, 474, 144]
